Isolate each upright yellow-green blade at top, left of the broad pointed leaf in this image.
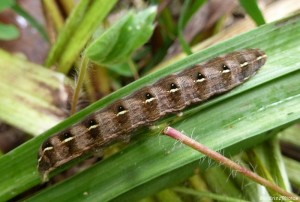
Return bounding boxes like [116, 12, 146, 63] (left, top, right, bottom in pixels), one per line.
[46, 0, 116, 73]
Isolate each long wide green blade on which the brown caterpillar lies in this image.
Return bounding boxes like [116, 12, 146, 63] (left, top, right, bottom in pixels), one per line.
[0, 14, 300, 201]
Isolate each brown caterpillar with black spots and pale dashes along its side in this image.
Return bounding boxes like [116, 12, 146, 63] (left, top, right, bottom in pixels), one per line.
[38, 49, 267, 180]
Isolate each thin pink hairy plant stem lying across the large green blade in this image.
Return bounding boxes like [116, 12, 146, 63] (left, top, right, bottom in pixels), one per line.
[164, 127, 300, 201]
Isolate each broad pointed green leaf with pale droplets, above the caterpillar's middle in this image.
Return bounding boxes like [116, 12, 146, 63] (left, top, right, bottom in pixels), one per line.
[86, 7, 156, 65]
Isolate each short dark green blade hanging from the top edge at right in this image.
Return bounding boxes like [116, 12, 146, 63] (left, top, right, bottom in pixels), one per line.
[240, 0, 266, 26]
